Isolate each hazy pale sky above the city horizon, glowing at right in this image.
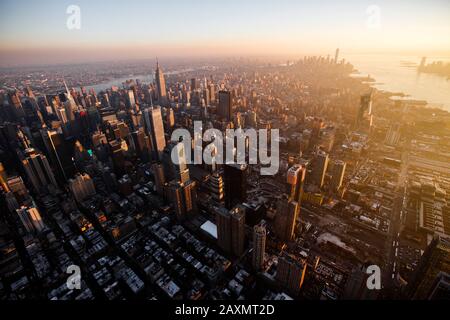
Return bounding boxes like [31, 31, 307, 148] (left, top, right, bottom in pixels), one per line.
[0, 0, 450, 66]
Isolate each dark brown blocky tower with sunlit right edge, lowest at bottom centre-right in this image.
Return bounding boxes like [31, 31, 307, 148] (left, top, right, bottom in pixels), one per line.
[276, 252, 307, 295]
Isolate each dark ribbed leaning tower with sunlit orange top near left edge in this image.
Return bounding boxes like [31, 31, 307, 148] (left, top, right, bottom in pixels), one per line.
[22, 148, 58, 193]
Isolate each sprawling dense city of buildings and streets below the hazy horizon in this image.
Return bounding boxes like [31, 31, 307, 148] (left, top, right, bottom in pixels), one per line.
[0, 0, 450, 302]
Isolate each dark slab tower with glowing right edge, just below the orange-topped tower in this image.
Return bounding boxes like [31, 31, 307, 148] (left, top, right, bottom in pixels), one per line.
[275, 199, 300, 242]
